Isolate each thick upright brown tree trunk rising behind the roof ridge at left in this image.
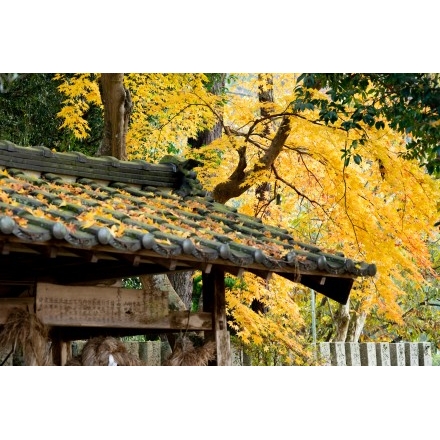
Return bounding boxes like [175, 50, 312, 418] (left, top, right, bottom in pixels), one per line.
[98, 73, 133, 160]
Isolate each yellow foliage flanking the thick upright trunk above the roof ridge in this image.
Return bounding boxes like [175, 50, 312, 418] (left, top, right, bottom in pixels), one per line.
[54, 73, 220, 162]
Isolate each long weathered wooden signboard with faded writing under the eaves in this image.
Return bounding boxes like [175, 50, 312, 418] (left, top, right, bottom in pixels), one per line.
[36, 283, 212, 330]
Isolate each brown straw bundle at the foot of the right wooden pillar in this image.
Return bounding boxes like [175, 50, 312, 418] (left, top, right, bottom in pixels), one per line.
[164, 336, 215, 367]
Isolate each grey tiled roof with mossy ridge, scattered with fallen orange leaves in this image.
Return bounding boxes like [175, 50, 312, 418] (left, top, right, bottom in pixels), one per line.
[0, 141, 376, 302]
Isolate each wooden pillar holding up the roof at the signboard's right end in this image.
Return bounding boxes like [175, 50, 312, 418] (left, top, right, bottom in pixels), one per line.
[203, 267, 232, 366]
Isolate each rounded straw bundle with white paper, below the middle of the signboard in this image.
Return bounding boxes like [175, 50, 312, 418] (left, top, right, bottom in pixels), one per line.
[81, 336, 141, 366]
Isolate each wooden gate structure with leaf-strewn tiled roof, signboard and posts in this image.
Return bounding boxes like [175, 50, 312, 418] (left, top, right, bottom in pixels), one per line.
[0, 141, 376, 365]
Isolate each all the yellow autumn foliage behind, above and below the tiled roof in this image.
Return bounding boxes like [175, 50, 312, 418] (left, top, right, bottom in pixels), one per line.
[54, 73, 440, 362]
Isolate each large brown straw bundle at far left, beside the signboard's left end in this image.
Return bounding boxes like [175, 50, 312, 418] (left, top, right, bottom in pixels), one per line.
[0, 308, 50, 366]
